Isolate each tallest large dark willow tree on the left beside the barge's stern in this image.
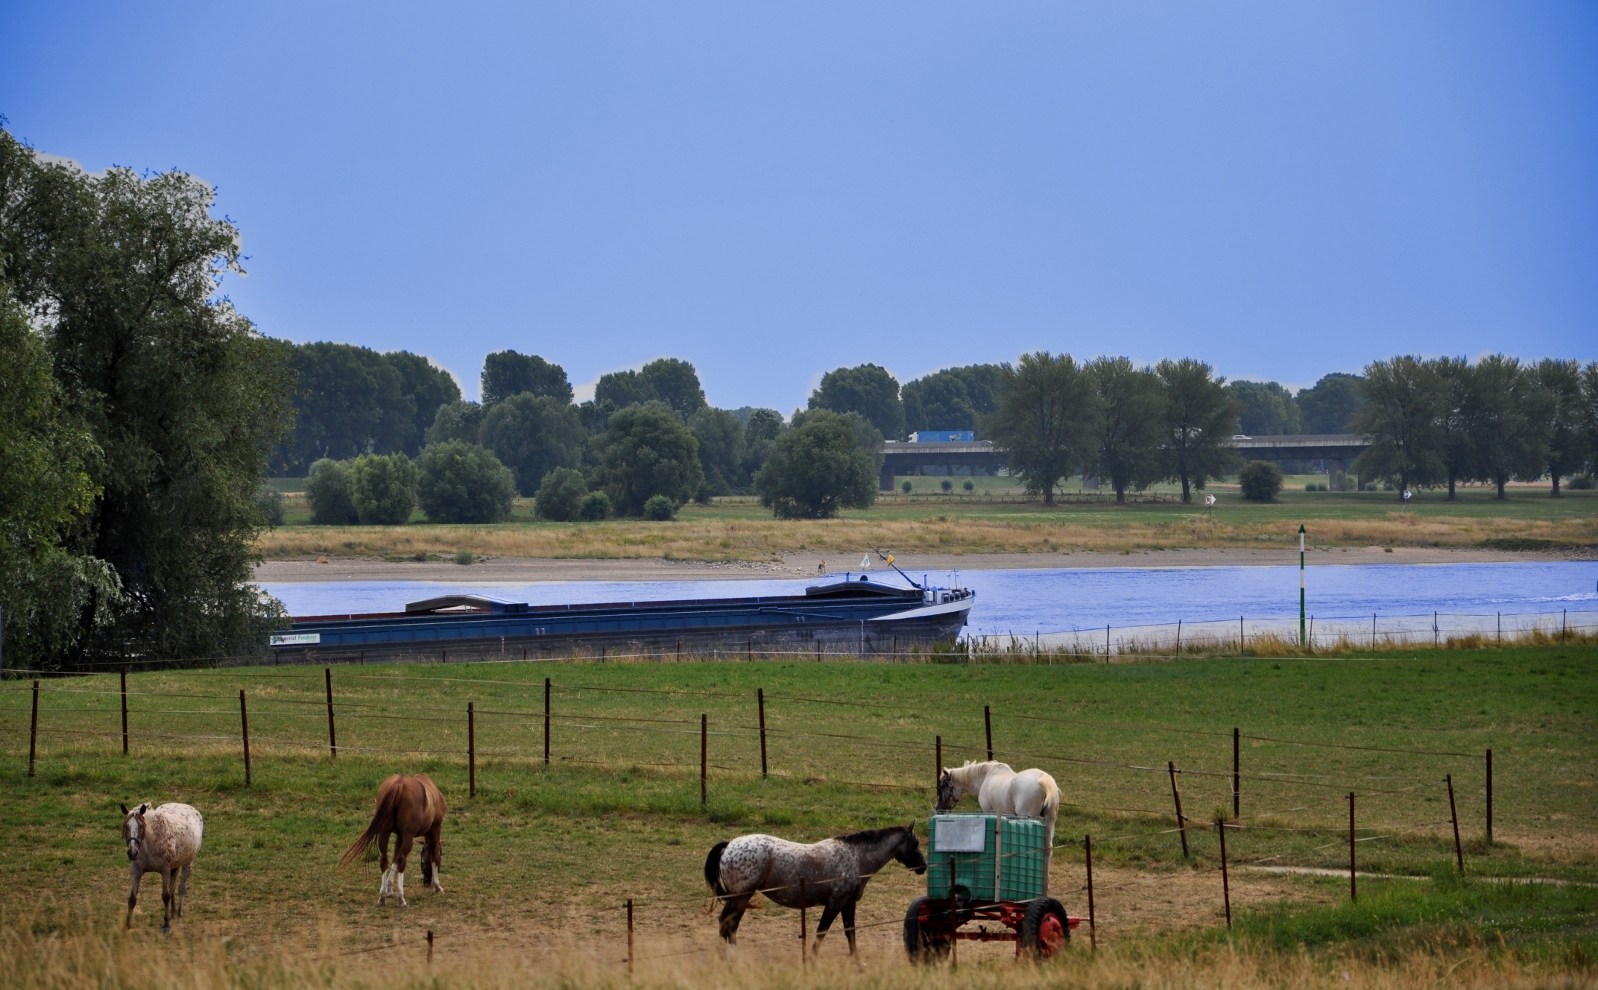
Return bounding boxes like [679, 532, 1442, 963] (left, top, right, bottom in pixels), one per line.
[0, 131, 289, 666]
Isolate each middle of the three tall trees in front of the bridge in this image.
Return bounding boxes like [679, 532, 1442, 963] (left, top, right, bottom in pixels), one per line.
[1082, 358, 1162, 503]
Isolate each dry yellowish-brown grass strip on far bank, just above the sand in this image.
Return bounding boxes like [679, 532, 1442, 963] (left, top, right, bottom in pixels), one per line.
[257, 506, 1598, 560]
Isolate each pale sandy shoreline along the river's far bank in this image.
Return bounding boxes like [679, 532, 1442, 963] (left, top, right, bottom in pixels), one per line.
[256, 546, 1571, 584]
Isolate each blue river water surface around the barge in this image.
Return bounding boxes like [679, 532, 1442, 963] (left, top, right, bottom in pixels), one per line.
[264, 557, 1598, 642]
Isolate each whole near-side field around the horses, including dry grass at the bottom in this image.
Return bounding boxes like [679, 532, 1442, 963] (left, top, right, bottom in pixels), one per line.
[0, 645, 1598, 987]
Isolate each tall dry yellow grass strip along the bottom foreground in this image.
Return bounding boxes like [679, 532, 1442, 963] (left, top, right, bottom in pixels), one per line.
[0, 907, 1598, 990]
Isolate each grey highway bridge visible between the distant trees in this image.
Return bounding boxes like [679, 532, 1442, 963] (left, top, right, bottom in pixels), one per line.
[879, 433, 1369, 492]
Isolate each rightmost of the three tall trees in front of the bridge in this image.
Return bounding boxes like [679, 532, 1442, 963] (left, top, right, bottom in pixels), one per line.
[1154, 358, 1242, 505]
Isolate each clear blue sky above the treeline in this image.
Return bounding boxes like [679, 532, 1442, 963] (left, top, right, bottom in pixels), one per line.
[0, 0, 1598, 412]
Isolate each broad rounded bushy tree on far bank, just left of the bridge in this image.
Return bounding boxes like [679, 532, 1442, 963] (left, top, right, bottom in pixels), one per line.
[754, 409, 880, 519]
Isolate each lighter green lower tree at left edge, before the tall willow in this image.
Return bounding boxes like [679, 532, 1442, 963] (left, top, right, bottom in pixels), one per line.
[0, 284, 121, 667]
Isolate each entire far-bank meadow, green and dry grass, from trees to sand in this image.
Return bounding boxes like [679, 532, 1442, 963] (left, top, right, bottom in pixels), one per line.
[257, 479, 1598, 560]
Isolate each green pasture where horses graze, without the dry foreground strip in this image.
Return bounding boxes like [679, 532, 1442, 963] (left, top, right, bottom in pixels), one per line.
[0, 647, 1598, 951]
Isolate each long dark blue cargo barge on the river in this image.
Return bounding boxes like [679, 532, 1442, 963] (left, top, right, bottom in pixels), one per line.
[270, 575, 976, 664]
